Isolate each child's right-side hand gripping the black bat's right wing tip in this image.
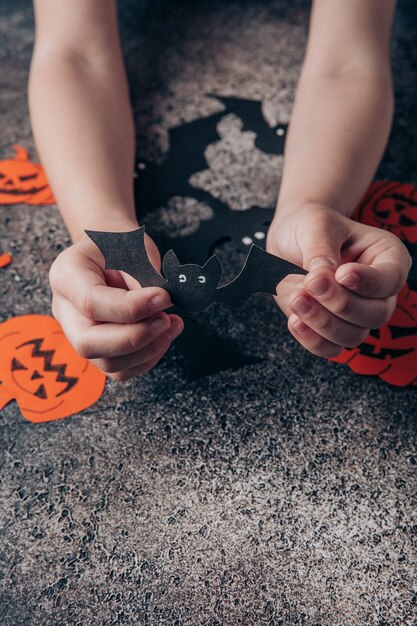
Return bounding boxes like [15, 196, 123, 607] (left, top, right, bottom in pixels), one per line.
[267, 205, 411, 357]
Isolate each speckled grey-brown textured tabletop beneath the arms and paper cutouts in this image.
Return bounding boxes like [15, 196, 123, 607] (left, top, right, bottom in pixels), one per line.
[0, 0, 417, 626]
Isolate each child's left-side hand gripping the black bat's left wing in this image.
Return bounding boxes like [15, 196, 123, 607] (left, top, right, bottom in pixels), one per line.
[50, 230, 183, 381]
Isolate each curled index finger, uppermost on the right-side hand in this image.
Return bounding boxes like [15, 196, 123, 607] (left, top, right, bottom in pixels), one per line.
[335, 245, 411, 298]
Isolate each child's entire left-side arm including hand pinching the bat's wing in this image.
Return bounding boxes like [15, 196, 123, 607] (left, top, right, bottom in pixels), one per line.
[29, 0, 182, 380]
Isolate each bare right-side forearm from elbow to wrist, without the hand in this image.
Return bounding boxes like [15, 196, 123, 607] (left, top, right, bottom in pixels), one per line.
[276, 64, 393, 218]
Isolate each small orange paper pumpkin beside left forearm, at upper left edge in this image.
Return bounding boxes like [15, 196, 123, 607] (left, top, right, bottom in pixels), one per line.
[0, 145, 55, 204]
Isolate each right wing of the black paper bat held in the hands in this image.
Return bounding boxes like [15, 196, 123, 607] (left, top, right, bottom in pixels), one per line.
[216, 245, 307, 307]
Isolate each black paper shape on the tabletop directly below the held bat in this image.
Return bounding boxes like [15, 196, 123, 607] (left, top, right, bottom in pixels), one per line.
[170, 307, 264, 380]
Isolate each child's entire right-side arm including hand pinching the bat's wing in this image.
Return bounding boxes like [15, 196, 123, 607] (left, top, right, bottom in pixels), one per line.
[268, 0, 410, 356]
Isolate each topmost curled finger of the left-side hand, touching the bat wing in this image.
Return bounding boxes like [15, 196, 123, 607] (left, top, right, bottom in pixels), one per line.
[50, 255, 172, 323]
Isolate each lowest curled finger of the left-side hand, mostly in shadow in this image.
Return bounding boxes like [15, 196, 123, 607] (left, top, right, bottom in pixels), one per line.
[93, 318, 182, 374]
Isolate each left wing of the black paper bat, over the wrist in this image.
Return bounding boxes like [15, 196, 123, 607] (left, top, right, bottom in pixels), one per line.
[85, 226, 167, 287]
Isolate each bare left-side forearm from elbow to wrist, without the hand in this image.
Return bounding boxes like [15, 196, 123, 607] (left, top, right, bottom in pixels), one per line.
[29, 49, 136, 240]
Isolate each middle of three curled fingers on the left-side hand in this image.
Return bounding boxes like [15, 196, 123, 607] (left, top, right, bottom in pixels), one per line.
[54, 299, 180, 359]
